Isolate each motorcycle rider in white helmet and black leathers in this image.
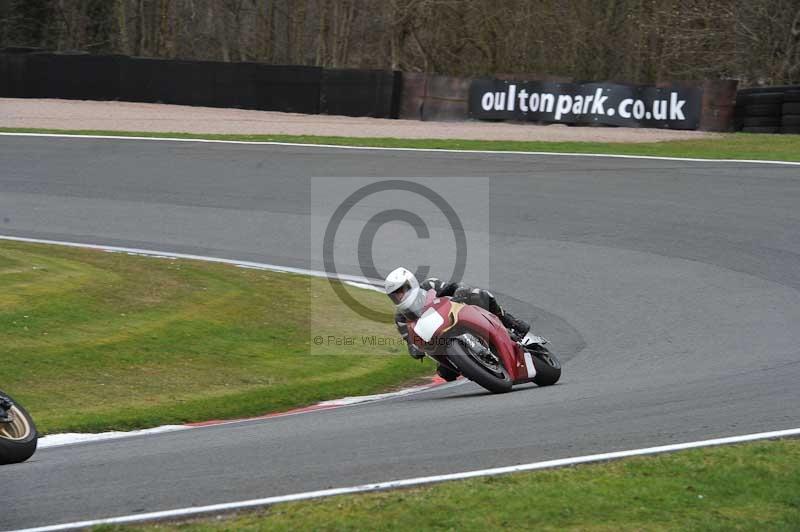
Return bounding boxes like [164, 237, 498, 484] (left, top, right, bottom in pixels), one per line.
[384, 267, 531, 381]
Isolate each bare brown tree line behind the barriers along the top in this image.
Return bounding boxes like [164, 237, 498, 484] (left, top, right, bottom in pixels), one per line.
[0, 0, 800, 85]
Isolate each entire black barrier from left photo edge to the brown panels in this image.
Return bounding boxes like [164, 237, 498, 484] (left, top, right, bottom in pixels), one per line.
[0, 52, 402, 118]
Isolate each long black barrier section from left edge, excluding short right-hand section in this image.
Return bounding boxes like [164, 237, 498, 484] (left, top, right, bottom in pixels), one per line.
[0, 53, 322, 114]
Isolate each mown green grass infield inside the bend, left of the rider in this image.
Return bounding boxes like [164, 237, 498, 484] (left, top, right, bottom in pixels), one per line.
[0, 241, 434, 433]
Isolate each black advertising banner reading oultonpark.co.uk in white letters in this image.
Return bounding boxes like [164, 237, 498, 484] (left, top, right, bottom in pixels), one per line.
[469, 79, 703, 129]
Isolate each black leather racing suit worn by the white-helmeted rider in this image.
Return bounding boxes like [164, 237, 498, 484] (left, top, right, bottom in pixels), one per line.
[394, 277, 531, 370]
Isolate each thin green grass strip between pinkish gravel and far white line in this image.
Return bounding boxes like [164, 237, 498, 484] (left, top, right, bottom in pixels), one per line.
[0, 126, 800, 161]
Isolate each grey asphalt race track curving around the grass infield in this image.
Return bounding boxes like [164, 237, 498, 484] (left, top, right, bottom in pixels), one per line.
[0, 137, 800, 529]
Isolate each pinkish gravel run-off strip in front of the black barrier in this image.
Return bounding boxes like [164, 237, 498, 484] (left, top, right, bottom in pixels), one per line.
[0, 98, 714, 142]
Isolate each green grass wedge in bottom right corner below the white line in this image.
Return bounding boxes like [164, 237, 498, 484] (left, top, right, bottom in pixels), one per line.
[103, 440, 800, 532]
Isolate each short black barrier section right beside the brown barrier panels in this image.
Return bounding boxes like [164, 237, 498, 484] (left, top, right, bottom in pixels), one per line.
[320, 69, 402, 118]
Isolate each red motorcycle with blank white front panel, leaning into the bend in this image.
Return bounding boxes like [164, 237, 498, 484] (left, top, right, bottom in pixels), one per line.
[408, 290, 561, 393]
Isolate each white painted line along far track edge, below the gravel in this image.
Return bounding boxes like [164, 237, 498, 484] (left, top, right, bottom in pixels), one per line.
[0, 132, 800, 166]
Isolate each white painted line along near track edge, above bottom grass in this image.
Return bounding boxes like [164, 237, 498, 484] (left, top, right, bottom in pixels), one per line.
[10, 428, 800, 532]
